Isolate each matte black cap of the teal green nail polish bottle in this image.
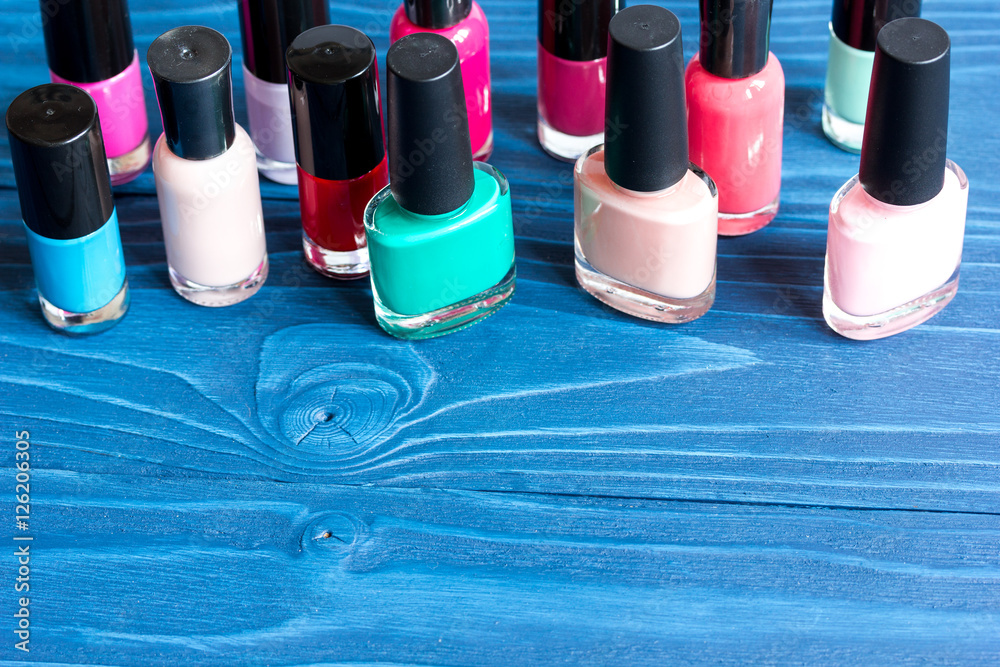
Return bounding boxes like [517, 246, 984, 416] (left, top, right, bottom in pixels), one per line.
[385, 32, 475, 215]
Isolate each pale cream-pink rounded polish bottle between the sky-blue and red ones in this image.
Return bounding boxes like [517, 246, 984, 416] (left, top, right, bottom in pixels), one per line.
[146, 26, 267, 306]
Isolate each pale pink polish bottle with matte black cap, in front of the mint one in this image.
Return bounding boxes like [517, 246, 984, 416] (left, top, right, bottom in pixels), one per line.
[823, 18, 969, 340]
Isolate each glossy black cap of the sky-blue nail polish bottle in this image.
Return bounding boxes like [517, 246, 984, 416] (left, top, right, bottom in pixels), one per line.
[7, 83, 115, 240]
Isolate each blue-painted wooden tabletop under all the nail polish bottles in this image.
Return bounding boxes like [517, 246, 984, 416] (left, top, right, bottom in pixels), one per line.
[0, 0, 1000, 665]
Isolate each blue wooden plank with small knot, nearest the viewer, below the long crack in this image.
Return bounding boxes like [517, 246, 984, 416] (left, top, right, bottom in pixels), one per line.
[5, 471, 1000, 665]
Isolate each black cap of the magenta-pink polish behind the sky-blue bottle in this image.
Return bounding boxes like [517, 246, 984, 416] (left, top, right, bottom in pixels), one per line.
[39, 0, 135, 83]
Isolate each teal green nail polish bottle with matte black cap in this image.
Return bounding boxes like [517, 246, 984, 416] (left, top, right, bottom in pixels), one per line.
[365, 33, 514, 339]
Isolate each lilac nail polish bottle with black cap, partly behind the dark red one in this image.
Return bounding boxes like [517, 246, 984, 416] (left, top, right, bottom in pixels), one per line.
[239, 0, 330, 185]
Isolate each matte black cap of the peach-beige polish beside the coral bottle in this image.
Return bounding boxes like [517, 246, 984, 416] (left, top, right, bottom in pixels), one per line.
[604, 5, 688, 192]
